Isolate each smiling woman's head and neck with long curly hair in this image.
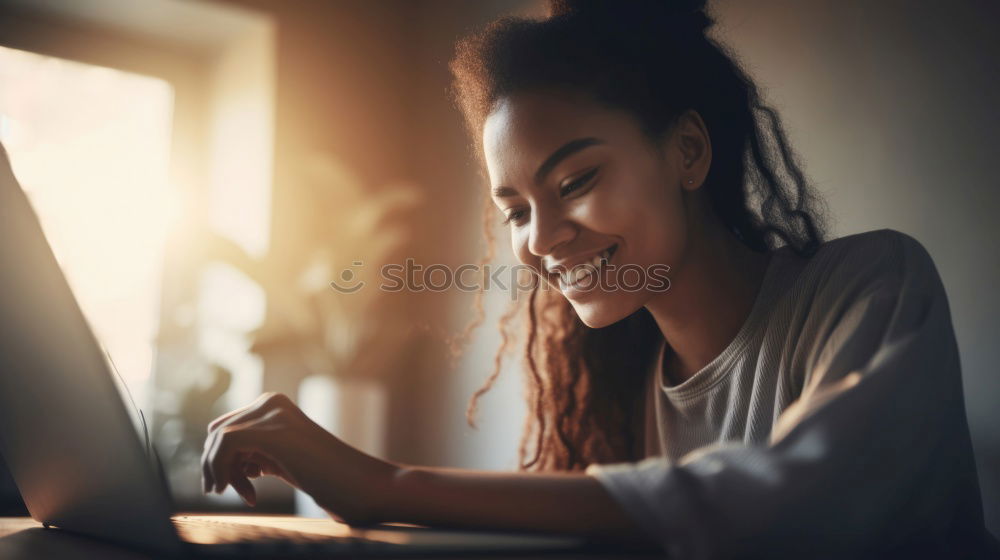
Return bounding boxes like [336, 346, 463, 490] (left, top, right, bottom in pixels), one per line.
[452, 2, 824, 469]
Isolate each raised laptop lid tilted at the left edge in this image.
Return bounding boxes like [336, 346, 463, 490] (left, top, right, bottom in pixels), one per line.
[0, 145, 181, 552]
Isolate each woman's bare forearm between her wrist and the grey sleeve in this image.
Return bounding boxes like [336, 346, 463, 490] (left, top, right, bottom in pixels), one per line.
[378, 466, 649, 543]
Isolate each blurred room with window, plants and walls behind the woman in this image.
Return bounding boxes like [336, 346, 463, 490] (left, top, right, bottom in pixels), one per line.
[0, 0, 1000, 533]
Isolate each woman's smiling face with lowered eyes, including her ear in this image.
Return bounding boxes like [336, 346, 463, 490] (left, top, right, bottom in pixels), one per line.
[483, 92, 711, 327]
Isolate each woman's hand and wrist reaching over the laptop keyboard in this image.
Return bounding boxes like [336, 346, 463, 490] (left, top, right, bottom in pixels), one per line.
[201, 393, 398, 524]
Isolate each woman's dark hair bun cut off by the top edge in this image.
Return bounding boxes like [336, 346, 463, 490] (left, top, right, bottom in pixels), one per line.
[548, 0, 713, 33]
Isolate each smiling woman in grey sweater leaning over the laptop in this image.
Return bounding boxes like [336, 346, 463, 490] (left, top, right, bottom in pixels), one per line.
[203, 0, 985, 558]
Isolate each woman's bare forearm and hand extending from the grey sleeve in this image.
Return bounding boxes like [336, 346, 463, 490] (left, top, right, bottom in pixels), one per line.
[202, 394, 651, 544]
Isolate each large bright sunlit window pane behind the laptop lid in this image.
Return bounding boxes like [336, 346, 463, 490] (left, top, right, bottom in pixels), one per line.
[0, 43, 176, 406]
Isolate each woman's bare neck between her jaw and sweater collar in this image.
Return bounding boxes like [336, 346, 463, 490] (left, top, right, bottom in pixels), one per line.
[646, 208, 773, 384]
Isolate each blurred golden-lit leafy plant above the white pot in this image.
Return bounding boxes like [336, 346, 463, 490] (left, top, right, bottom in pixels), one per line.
[240, 154, 422, 377]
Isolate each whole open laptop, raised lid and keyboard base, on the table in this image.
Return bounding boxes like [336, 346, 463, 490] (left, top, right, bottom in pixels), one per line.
[0, 142, 585, 556]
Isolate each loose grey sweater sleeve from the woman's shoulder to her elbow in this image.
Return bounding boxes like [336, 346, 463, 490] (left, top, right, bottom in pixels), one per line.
[587, 234, 982, 558]
